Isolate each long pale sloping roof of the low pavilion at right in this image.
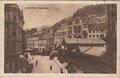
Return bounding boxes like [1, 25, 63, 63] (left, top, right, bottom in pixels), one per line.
[64, 38, 105, 44]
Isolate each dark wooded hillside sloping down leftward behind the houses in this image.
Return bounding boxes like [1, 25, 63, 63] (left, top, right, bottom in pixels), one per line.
[52, 4, 106, 31]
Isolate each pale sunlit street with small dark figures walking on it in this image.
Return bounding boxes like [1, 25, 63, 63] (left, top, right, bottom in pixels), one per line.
[31, 55, 67, 73]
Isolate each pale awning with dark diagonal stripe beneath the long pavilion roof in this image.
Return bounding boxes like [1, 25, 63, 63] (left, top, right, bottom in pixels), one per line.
[79, 46, 106, 56]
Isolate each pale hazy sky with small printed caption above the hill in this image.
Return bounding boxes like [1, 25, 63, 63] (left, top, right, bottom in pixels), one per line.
[18, 4, 87, 29]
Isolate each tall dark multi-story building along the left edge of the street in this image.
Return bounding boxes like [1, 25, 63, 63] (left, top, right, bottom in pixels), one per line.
[4, 4, 24, 73]
